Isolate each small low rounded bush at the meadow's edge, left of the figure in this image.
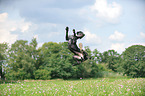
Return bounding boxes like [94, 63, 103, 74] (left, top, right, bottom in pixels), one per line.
[34, 69, 51, 80]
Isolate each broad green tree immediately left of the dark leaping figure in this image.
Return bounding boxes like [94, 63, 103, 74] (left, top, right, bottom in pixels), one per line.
[39, 42, 73, 79]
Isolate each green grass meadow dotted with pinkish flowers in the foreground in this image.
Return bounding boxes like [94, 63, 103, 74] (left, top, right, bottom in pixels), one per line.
[0, 78, 145, 96]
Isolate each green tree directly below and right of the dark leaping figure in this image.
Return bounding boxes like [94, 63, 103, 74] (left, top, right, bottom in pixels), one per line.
[76, 46, 104, 78]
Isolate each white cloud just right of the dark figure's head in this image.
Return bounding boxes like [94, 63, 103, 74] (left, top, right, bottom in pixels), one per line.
[84, 29, 101, 44]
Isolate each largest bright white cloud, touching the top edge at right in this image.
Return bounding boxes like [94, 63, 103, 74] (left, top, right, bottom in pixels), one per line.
[91, 0, 122, 22]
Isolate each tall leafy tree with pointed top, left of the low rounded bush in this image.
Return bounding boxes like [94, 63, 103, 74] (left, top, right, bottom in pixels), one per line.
[5, 39, 37, 80]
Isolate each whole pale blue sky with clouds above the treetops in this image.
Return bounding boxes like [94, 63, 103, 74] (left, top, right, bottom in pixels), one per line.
[0, 0, 145, 53]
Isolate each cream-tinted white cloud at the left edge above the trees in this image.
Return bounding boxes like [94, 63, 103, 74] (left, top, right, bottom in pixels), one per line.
[0, 13, 31, 44]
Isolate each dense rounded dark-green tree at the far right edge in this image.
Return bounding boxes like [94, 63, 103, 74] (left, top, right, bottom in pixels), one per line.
[122, 45, 145, 77]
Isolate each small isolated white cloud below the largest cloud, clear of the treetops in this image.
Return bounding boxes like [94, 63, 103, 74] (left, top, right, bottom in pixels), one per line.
[109, 31, 125, 41]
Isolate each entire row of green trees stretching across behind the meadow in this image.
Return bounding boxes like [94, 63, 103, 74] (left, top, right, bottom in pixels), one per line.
[0, 38, 145, 80]
